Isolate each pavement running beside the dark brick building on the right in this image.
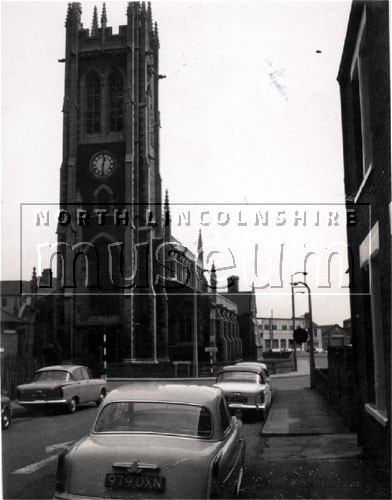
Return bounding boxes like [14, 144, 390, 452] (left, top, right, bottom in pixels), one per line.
[247, 359, 391, 499]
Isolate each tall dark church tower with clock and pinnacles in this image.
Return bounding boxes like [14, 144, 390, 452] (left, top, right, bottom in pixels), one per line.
[56, 2, 167, 365]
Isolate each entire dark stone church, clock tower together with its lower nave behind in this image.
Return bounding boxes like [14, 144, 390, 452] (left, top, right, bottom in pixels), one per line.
[8, 2, 256, 376]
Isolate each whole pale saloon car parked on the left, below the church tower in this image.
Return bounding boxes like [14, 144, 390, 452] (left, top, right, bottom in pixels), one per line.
[16, 365, 106, 413]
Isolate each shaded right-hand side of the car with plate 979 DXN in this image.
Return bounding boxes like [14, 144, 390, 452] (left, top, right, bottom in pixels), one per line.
[219, 398, 245, 498]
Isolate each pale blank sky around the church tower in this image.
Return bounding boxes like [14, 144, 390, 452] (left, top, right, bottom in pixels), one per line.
[1, 0, 351, 324]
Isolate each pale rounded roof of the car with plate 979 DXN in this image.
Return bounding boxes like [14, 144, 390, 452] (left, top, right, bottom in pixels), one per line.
[104, 381, 222, 408]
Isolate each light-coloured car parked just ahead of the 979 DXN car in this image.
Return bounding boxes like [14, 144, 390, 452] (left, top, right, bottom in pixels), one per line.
[214, 365, 272, 418]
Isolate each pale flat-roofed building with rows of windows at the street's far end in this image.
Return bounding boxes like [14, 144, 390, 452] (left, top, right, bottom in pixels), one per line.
[257, 316, 322, 351]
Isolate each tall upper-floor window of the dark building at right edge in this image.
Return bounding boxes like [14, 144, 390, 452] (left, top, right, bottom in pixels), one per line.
[351, 8, 372, 197]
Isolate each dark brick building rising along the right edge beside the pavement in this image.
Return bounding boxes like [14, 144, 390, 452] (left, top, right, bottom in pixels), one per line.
[338, 0, 391, 462]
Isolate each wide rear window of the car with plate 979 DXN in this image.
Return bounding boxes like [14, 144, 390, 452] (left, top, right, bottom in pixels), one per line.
[94, 401, 213, 439]
